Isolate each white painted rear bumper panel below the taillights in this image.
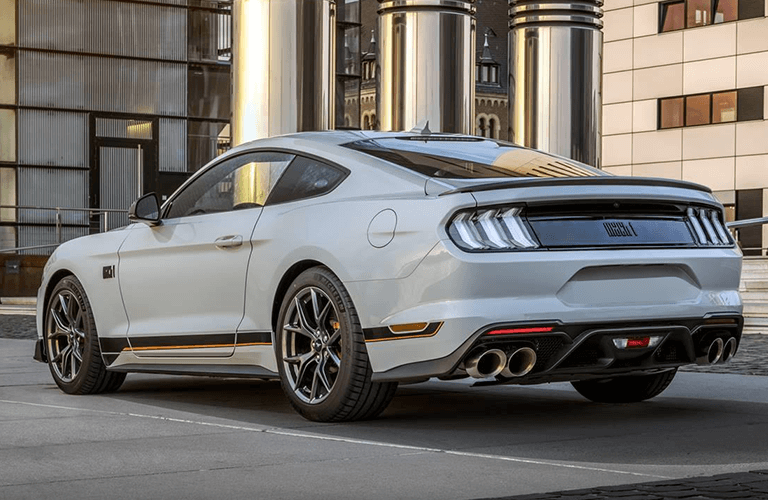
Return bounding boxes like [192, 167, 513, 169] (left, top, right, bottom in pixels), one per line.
[345, 240, 742, 376]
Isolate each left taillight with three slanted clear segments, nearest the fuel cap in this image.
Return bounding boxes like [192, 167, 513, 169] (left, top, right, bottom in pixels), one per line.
[448, 207, 540, 252]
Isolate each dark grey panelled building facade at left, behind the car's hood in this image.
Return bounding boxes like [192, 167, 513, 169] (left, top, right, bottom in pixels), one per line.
[0, 0, 231, 253]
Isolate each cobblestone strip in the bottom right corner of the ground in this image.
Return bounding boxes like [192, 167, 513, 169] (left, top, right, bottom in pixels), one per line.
[484, 470, 768, 500]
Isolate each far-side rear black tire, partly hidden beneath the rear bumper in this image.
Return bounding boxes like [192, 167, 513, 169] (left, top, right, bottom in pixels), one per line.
[571, 368, 677, 403]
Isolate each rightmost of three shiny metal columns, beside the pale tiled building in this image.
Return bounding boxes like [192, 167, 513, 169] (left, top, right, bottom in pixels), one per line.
[509, 0, 603, 167]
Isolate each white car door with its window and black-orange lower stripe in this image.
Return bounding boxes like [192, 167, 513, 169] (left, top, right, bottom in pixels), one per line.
[118, 152, 293, 357]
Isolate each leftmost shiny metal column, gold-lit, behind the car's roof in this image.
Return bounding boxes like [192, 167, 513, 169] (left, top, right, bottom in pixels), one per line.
[232, 0, 335, 145]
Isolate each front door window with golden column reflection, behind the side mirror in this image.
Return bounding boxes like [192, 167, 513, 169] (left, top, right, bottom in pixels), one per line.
[165, 152, 294, 219]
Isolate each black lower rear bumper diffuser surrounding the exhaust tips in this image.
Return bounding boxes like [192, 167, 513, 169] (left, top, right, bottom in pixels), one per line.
[373, 314, 744, 384]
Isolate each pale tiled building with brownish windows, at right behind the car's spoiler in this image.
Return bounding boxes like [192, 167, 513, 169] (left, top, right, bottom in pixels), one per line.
[602, 0, 768, 250]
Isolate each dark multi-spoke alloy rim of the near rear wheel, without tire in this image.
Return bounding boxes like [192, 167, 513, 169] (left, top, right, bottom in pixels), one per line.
[282, 286, 342, 404]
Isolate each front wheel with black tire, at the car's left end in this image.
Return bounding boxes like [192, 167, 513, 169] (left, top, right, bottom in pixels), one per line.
[43, 276, 125, 394]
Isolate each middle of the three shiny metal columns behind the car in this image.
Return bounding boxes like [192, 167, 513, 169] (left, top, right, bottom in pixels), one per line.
[377, 0, 475, 134]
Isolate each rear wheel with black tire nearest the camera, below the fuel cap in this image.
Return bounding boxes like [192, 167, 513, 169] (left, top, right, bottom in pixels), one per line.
[275, 267, 397, 422]
